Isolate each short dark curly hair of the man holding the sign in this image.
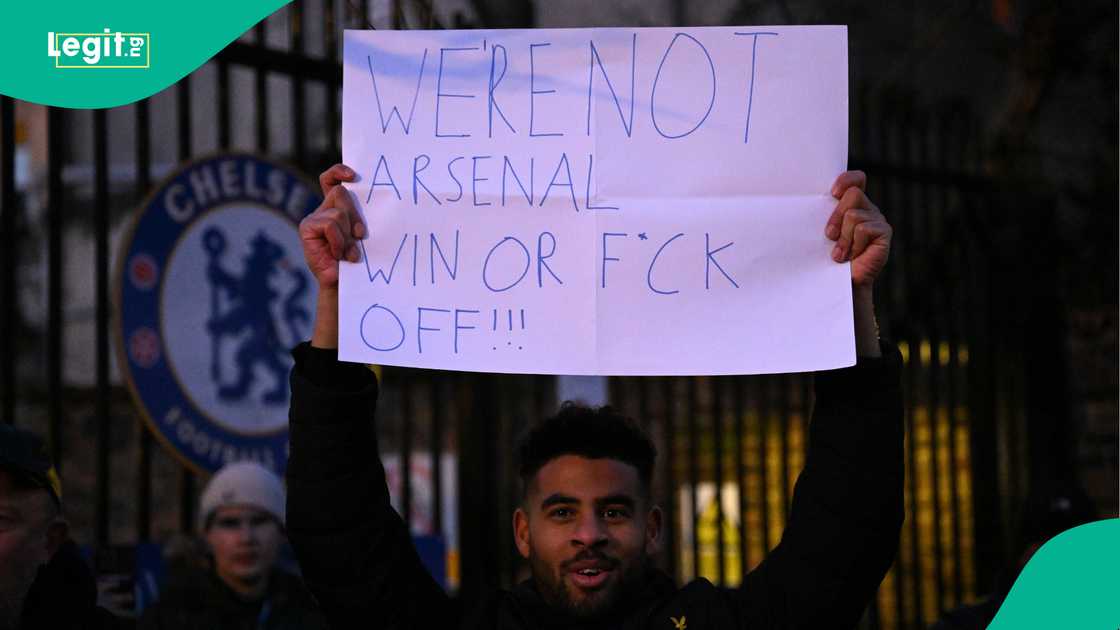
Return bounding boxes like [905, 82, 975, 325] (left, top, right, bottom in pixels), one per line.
[516, 400, 657, 495]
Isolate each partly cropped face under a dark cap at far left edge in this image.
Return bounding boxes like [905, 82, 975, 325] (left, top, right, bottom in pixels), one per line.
[0, 471, 56, 628]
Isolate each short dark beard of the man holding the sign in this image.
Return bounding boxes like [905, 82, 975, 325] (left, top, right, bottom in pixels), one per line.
[529, 549, 648, 619]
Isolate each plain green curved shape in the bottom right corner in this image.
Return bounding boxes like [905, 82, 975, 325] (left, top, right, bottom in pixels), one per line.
[988, 518, 1120, 630]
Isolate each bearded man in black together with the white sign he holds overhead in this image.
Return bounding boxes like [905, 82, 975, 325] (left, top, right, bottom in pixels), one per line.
[288, 26, 903, 630]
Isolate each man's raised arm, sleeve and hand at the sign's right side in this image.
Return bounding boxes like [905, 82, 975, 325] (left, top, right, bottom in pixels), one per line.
[732, 173, 903, 628]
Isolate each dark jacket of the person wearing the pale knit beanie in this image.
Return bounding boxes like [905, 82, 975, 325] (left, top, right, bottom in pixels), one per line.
[140, 571, 327, 630]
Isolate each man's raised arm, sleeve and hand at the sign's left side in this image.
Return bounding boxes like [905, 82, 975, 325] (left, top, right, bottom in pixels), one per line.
[287, 166, 448, 628]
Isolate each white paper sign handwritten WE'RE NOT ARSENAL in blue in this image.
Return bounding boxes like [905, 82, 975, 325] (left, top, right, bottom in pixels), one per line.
[339, 27, 856, 374]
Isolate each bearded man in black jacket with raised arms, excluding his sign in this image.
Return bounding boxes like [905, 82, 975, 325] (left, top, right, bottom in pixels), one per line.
[288, 159, 903, 630]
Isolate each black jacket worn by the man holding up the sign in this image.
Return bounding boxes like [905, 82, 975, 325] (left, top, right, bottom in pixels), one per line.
[288, 343, 903, 630]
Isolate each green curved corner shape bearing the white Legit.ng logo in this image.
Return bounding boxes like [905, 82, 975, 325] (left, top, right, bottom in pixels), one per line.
[0, 0, 290, 109]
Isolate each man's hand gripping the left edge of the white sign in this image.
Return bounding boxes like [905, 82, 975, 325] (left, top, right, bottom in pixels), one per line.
[299, 164, 366, 290]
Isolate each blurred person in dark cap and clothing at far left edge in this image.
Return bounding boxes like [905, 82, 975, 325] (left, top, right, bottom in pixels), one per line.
[0, 424, 130, 630]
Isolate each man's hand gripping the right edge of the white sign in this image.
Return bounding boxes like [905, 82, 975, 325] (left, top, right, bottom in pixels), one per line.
[824, 170, 893, 288]
